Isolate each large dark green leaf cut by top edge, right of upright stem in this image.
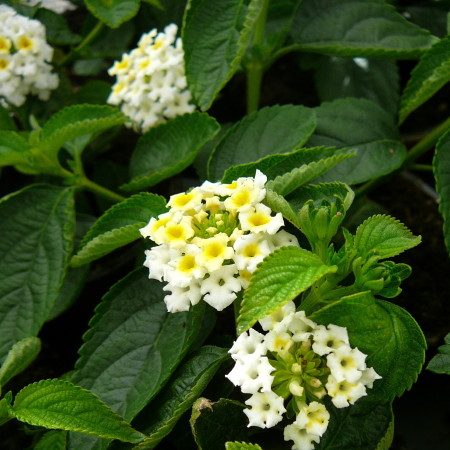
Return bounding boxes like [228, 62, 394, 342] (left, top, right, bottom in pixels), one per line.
[291, 0, 437, 58]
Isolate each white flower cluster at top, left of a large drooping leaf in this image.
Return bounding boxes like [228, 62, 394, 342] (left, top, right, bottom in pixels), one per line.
[108, 24, 195, 132]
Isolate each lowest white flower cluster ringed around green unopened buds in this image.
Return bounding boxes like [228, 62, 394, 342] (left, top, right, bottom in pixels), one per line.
[227, 302, 381, 450]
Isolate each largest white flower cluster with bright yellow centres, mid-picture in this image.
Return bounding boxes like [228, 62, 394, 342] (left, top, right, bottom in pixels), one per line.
[140, 171, 298, 312]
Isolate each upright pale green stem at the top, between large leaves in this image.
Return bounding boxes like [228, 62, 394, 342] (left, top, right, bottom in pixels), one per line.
[246, 0, 269, 114]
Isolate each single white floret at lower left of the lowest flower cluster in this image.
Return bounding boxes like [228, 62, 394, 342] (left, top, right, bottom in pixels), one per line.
[244, 391, 286, 428]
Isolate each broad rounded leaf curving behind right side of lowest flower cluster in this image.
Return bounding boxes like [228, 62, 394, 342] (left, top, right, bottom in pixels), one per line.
[311, 292, 426, 400]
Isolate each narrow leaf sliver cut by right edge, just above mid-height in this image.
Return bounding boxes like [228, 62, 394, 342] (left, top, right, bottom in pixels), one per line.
[433, 130, 450, 254]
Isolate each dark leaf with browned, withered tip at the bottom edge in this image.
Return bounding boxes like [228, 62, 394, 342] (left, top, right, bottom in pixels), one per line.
[191, 398, 248, 450]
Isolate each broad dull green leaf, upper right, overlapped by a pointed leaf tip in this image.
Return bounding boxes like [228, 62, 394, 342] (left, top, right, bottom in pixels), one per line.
[308, 98, 406, 184]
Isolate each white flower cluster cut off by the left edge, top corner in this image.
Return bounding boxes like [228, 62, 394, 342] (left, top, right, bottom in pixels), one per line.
[0, 5, 59, 106]
